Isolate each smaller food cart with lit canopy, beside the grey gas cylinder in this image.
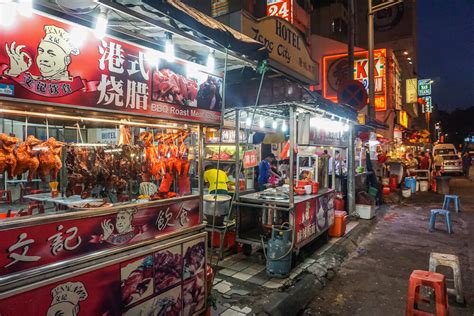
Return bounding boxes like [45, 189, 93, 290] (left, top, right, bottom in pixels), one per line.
[230, 99, 352, 253]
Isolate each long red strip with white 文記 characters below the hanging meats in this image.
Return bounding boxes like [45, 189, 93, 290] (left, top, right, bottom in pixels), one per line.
[0, 198, 201, 276]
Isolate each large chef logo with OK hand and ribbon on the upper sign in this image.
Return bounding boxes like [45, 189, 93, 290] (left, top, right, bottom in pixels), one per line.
[0, 25, 96, 97]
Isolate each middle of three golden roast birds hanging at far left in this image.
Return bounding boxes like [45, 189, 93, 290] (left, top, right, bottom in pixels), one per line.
[13, 135, 42, 181]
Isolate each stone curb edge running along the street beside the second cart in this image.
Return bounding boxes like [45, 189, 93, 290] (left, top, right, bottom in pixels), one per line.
[263, 207, 389, 316]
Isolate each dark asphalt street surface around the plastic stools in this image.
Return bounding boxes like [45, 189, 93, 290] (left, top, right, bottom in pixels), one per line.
[305, 178, 474, 316]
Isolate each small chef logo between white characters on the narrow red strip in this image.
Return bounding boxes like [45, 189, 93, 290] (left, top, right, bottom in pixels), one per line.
[90, 208, 142, 245]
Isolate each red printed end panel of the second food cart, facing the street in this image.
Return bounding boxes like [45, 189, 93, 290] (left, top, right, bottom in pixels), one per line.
[295, 191, 334, 246]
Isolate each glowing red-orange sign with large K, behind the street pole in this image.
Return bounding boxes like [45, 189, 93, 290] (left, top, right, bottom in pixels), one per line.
[323, 49, 388, 111]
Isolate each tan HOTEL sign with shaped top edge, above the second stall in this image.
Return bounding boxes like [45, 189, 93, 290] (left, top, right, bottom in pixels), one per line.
[242, 13, 319, 84]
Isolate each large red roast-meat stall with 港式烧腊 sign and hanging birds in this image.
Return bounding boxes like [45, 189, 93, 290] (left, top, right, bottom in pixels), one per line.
[0, 1, 261, 315]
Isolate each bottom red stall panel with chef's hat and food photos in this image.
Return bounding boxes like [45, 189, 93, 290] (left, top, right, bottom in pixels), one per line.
[0, 234, 206, 316]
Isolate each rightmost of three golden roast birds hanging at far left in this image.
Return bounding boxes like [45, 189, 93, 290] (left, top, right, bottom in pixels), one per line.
[38, 137, 65, 181]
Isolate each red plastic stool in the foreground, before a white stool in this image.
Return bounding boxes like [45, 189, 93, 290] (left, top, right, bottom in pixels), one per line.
[405, 270, 449, 316]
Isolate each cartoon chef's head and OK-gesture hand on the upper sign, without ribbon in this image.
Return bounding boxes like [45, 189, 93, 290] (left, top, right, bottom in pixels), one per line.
[5, 25, 79, 81]
